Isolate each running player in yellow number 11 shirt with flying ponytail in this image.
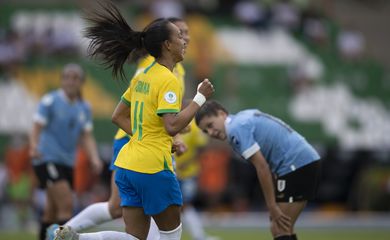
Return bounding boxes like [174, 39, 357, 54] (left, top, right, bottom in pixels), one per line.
[56, 4, 214, 240]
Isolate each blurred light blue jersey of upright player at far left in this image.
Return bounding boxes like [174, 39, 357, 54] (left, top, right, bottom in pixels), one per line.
[33, 90, 92, 167]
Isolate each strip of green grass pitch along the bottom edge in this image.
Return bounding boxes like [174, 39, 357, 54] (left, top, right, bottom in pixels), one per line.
[0, 228, 390, 240]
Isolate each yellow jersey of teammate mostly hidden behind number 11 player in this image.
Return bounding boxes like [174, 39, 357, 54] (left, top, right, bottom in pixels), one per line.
[114, 55, 186, 139]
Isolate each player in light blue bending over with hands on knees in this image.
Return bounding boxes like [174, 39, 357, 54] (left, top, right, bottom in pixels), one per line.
[195, 101, 320, 240]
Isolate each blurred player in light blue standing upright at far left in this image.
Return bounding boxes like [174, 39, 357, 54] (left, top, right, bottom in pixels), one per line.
[30, 64, 102, 240]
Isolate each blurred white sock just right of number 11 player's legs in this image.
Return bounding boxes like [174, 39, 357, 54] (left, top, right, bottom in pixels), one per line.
[183, 206, 206, 239]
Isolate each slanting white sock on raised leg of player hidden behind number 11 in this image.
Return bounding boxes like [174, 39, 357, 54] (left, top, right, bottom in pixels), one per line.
[65, 202, 112, 232]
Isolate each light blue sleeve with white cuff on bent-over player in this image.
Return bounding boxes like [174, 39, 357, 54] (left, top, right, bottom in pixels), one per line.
[229, 123, 260, 159]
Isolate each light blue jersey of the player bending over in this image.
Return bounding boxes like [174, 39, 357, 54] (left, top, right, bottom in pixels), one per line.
[225, 109, 320, 176]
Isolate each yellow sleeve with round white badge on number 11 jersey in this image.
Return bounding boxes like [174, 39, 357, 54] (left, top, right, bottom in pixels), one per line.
[157, 76, 182, 115]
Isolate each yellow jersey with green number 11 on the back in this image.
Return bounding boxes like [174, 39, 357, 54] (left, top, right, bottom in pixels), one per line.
[115, 62, 182, 173]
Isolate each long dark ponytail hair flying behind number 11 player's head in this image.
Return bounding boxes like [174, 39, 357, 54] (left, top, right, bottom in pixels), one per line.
[85, 2, 171, 79]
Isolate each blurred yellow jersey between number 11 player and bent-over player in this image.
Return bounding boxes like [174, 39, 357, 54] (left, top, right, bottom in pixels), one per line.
[175, 120, 207, 180]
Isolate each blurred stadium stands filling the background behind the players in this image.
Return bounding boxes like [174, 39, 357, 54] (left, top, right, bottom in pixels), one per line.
[0, 0, 390, 239]
